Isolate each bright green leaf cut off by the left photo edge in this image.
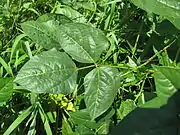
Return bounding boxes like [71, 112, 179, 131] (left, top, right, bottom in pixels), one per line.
[0, 77, 13, 106]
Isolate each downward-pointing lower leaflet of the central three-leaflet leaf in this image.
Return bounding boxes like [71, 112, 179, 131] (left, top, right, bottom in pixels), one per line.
[84, 67, 120, 119]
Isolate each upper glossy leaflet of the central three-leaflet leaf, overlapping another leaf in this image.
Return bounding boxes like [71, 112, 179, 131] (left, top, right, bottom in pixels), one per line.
[56, 23, 109, 63]
